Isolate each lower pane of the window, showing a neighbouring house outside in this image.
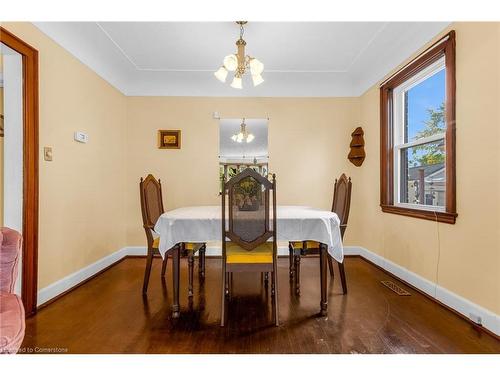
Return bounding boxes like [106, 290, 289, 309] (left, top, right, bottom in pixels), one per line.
[399, 139, 446, 207]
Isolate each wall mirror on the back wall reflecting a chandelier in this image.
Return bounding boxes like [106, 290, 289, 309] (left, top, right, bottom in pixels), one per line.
[219, 118, 269, 187]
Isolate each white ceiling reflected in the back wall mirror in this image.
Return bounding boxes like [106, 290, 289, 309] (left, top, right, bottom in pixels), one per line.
[219, 118, 268, 161]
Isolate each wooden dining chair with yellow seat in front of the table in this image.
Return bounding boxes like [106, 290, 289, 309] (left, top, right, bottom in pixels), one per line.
[221, 168, 279, 326]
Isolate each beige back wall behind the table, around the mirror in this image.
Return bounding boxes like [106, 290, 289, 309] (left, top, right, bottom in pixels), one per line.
[126, 97, 359, 246]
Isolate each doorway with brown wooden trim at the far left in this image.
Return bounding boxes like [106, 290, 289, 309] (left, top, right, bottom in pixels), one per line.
[0, 27, 38, 317]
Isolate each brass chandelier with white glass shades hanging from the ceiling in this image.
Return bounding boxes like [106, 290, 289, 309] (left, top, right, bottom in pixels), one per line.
[214, 21, 264, 89]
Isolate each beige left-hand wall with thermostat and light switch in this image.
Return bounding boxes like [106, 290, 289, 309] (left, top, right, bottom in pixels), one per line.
[2, 23, 126, 288]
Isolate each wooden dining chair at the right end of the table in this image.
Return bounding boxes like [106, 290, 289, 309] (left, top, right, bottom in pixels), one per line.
[288, 173, 352, 294]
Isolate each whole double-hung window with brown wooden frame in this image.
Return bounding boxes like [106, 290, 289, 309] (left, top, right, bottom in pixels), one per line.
[380, 31, 457, 223]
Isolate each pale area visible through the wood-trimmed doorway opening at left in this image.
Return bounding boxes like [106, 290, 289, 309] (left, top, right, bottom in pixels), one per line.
[0, 43, 23, 295]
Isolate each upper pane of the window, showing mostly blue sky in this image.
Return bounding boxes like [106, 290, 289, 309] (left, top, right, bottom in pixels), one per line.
[404, 68, 446, 143]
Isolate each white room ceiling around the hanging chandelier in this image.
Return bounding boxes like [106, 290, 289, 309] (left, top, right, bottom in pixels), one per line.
[35, 22, 449, 96]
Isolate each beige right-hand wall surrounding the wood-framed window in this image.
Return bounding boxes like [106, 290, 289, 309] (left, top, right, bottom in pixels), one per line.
[347, 23, 500, 313]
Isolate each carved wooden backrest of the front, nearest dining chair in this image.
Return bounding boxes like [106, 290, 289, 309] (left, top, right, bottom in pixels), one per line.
[222, 168, 276, 250]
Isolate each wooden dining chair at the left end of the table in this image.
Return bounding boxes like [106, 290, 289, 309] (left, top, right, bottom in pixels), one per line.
[139, 174, 206, 296]
